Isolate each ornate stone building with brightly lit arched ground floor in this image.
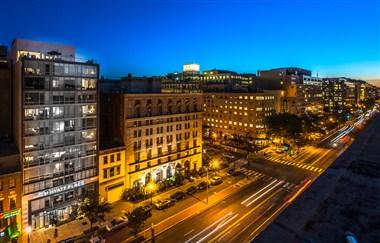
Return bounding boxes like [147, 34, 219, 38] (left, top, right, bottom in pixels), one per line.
[102, 93, 202, 188]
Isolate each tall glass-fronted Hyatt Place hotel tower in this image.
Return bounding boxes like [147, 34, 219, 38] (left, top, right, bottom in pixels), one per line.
[11, 39, 99, 228]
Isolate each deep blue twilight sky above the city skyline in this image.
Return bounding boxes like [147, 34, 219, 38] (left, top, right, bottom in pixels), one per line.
[0, 0, 380, 79]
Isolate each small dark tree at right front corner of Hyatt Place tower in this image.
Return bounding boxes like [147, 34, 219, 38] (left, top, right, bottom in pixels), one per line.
[78, 193, 111, 231]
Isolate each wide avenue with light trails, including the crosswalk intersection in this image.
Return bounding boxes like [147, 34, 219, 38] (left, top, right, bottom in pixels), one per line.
[155, 111, 378, 242]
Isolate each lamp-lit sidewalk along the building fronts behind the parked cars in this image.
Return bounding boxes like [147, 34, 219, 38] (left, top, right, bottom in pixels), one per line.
[21, 169, 227, 243]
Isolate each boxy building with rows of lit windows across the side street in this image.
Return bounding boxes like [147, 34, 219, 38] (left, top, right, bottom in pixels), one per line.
[203, 90, 283, 144]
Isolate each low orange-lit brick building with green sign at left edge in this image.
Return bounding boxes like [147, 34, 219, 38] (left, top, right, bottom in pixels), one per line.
[0, 142, 22, 242]
